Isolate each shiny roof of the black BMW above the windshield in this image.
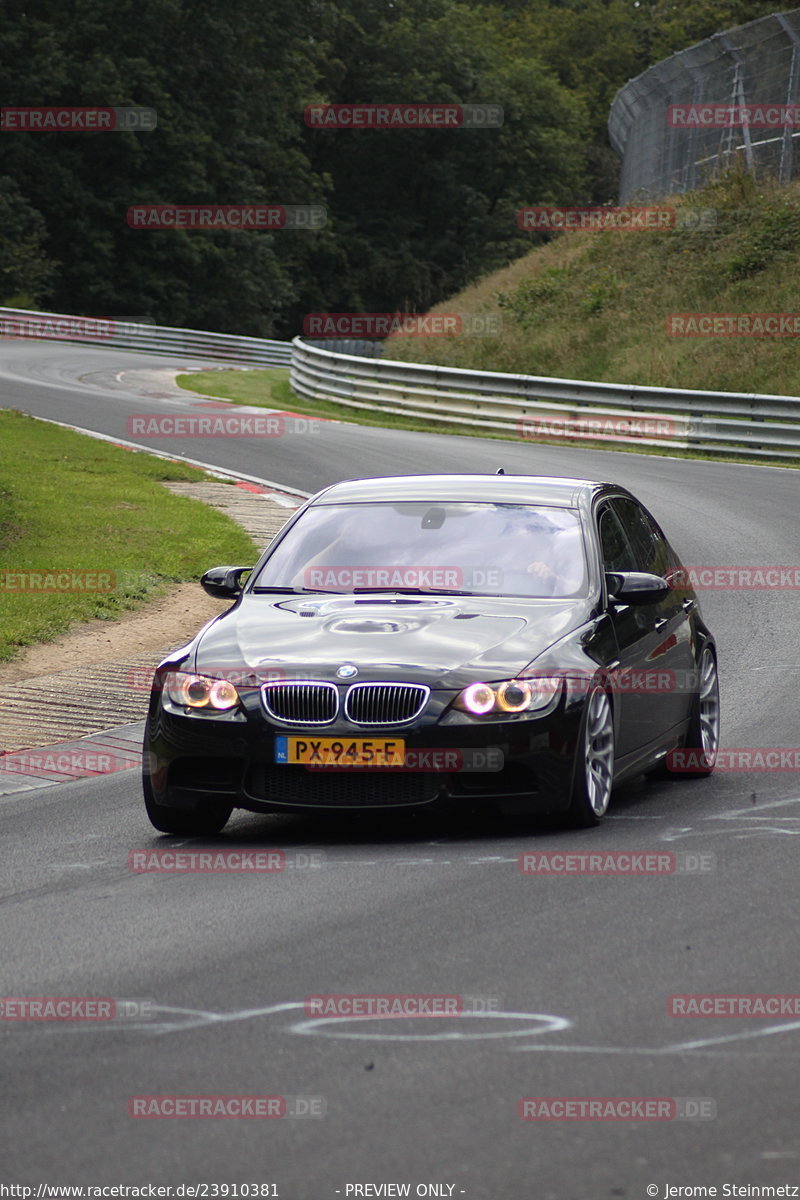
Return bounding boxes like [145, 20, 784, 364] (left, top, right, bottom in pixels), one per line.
[311, 474, 625, 508]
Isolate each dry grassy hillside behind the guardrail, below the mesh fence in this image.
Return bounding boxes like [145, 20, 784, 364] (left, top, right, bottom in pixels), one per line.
[384, 174, 800, 396]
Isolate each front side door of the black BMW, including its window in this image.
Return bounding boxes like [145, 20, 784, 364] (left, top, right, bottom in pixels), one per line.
[596, 500, 661, 757]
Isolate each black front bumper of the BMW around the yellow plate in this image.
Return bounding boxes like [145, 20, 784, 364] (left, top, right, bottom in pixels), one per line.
[144, 697, 582, 814]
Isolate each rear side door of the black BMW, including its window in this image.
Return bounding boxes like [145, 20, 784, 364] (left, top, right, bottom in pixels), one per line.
[610, 496, 694, 732]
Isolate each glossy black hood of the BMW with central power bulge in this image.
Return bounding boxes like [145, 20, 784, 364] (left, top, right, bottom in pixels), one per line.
[194, 594, 591, 688]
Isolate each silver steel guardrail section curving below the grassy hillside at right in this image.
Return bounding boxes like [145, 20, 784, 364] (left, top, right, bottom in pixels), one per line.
[291, 337, 800, 460]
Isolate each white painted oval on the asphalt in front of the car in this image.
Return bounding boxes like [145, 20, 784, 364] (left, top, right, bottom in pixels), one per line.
[290, 1013, 570, 1042]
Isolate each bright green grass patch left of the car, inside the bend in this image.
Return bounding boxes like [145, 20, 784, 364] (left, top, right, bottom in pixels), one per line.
[0, 410, 257, 661]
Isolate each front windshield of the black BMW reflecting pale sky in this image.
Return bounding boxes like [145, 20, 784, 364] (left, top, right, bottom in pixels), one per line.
[253, 502, 587, 598]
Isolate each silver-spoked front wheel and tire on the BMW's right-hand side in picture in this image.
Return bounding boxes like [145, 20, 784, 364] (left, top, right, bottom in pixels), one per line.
[567, 686, 614, 829]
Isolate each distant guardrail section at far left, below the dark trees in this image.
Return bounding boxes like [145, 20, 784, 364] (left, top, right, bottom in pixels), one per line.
[0, 308, 291, 367]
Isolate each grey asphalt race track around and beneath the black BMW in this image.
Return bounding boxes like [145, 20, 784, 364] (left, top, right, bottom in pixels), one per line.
[0, 342, 800, 1200]
